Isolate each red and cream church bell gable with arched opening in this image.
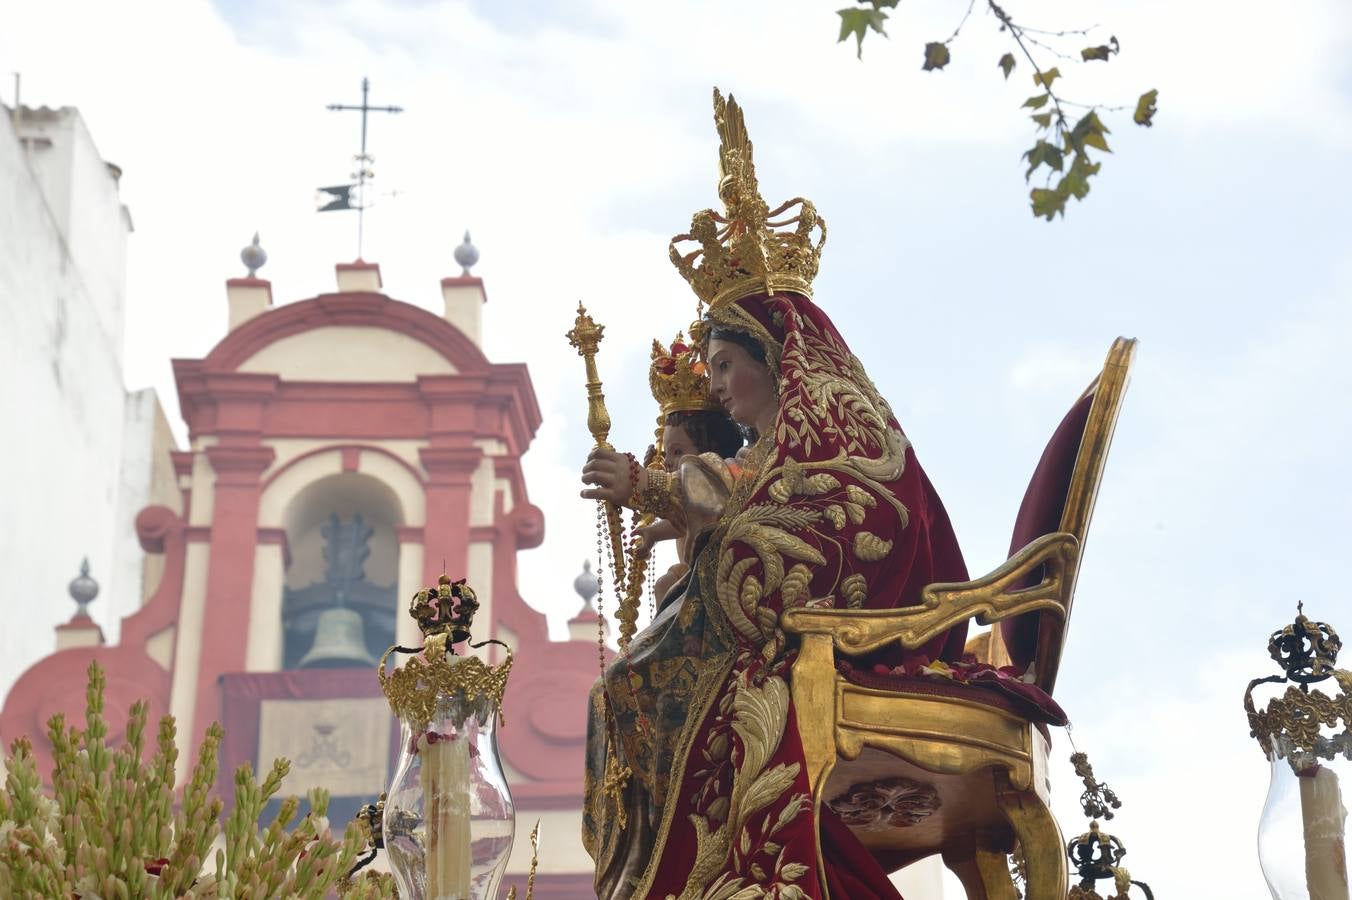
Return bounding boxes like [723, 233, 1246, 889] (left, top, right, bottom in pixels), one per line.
[0, 248, 596, 897]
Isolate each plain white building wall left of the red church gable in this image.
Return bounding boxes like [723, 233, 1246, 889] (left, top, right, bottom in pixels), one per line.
[0, 108, 162, 699]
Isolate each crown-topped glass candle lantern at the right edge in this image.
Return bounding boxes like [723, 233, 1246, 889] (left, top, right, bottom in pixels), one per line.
[1244, 603, 1352, 900]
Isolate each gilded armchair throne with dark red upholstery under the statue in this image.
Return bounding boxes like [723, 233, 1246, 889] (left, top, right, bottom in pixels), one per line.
[781, 338, 1137, 900]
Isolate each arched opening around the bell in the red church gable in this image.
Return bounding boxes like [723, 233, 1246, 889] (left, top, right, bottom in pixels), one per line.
[281, 472, 406, 669]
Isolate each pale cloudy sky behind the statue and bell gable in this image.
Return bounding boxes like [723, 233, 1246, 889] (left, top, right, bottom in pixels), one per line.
[0, 0, 1352, 900]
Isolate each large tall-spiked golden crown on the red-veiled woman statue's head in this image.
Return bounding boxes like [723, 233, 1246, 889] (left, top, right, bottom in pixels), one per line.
[671, 88, 826, 309]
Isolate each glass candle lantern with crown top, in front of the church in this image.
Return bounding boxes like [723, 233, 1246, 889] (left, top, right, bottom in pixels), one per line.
[377, 576, 516, 900]
